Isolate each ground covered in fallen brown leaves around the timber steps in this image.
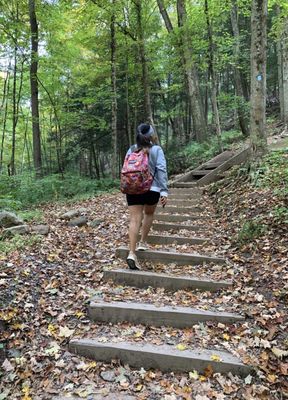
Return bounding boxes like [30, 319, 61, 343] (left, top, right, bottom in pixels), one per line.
[0, 170, 288, 400]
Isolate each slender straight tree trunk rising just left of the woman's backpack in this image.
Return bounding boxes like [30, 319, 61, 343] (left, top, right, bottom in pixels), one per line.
[110, 0, 118, 179]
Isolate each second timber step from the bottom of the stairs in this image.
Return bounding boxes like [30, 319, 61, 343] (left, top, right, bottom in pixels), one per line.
[88, 301, 244, 328]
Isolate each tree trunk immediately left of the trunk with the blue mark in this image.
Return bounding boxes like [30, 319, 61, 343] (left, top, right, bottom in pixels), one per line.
[230, 0, 249, 137]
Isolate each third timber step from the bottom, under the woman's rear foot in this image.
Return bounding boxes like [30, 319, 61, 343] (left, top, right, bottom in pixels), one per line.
[103, 269, 232, 292]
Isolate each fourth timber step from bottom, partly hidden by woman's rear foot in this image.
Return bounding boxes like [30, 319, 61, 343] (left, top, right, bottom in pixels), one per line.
[116, 247, 226, 265]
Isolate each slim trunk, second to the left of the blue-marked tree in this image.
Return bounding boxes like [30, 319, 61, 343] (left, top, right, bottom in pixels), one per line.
[205, 0, 223, 152]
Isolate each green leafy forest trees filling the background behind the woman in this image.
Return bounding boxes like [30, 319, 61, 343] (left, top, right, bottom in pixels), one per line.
[0, 0, 288, 179]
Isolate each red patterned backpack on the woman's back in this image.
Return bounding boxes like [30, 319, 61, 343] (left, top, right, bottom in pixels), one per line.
[120, 149, 154, 194]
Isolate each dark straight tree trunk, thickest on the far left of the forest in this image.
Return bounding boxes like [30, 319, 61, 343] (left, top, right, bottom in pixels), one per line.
[29, 0, 42, 177]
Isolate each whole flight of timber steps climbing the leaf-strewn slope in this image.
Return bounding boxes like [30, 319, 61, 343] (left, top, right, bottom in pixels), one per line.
[69, 185, 250, 376]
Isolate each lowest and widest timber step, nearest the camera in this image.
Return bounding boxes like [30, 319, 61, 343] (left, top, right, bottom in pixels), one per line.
[69, 339, 250, 376]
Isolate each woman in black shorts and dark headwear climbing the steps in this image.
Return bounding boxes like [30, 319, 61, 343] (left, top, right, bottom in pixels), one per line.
[126, 124, 168, 270]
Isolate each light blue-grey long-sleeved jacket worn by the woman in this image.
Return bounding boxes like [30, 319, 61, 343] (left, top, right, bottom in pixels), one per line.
[126, 145, 168, 197]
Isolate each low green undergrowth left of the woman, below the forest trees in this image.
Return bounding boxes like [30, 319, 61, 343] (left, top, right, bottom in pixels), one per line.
[0, 174, 119, 209]
